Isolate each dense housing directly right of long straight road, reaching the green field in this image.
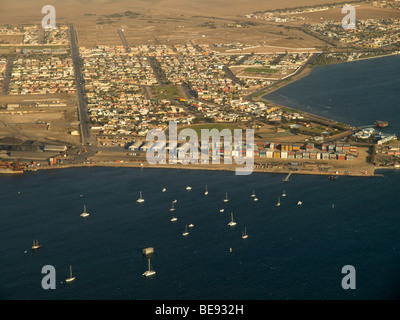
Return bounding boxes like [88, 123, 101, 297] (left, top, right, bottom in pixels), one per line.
[80, 46, 198, 139]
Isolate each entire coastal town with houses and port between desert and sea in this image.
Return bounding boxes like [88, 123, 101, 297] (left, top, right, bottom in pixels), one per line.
[0, 2, 400, 175]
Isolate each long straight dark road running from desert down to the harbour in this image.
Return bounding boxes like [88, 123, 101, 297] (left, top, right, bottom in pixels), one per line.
[69, 26, 96, 145]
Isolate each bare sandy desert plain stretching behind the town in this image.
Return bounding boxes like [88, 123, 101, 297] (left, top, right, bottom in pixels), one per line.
[0, 0, 399, 48]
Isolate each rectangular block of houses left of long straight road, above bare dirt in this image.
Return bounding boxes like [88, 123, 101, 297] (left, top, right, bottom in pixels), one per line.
[9, 56, 76, 95]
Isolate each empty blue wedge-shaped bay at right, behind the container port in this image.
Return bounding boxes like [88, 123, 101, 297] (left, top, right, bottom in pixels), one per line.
[263, 55, 400, 135]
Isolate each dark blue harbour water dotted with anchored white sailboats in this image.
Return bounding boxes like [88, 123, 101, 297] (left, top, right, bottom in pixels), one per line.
[0, 168, 400, 300]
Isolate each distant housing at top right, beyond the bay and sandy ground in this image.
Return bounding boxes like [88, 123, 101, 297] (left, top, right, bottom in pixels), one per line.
[304, 18, 400, 48]
